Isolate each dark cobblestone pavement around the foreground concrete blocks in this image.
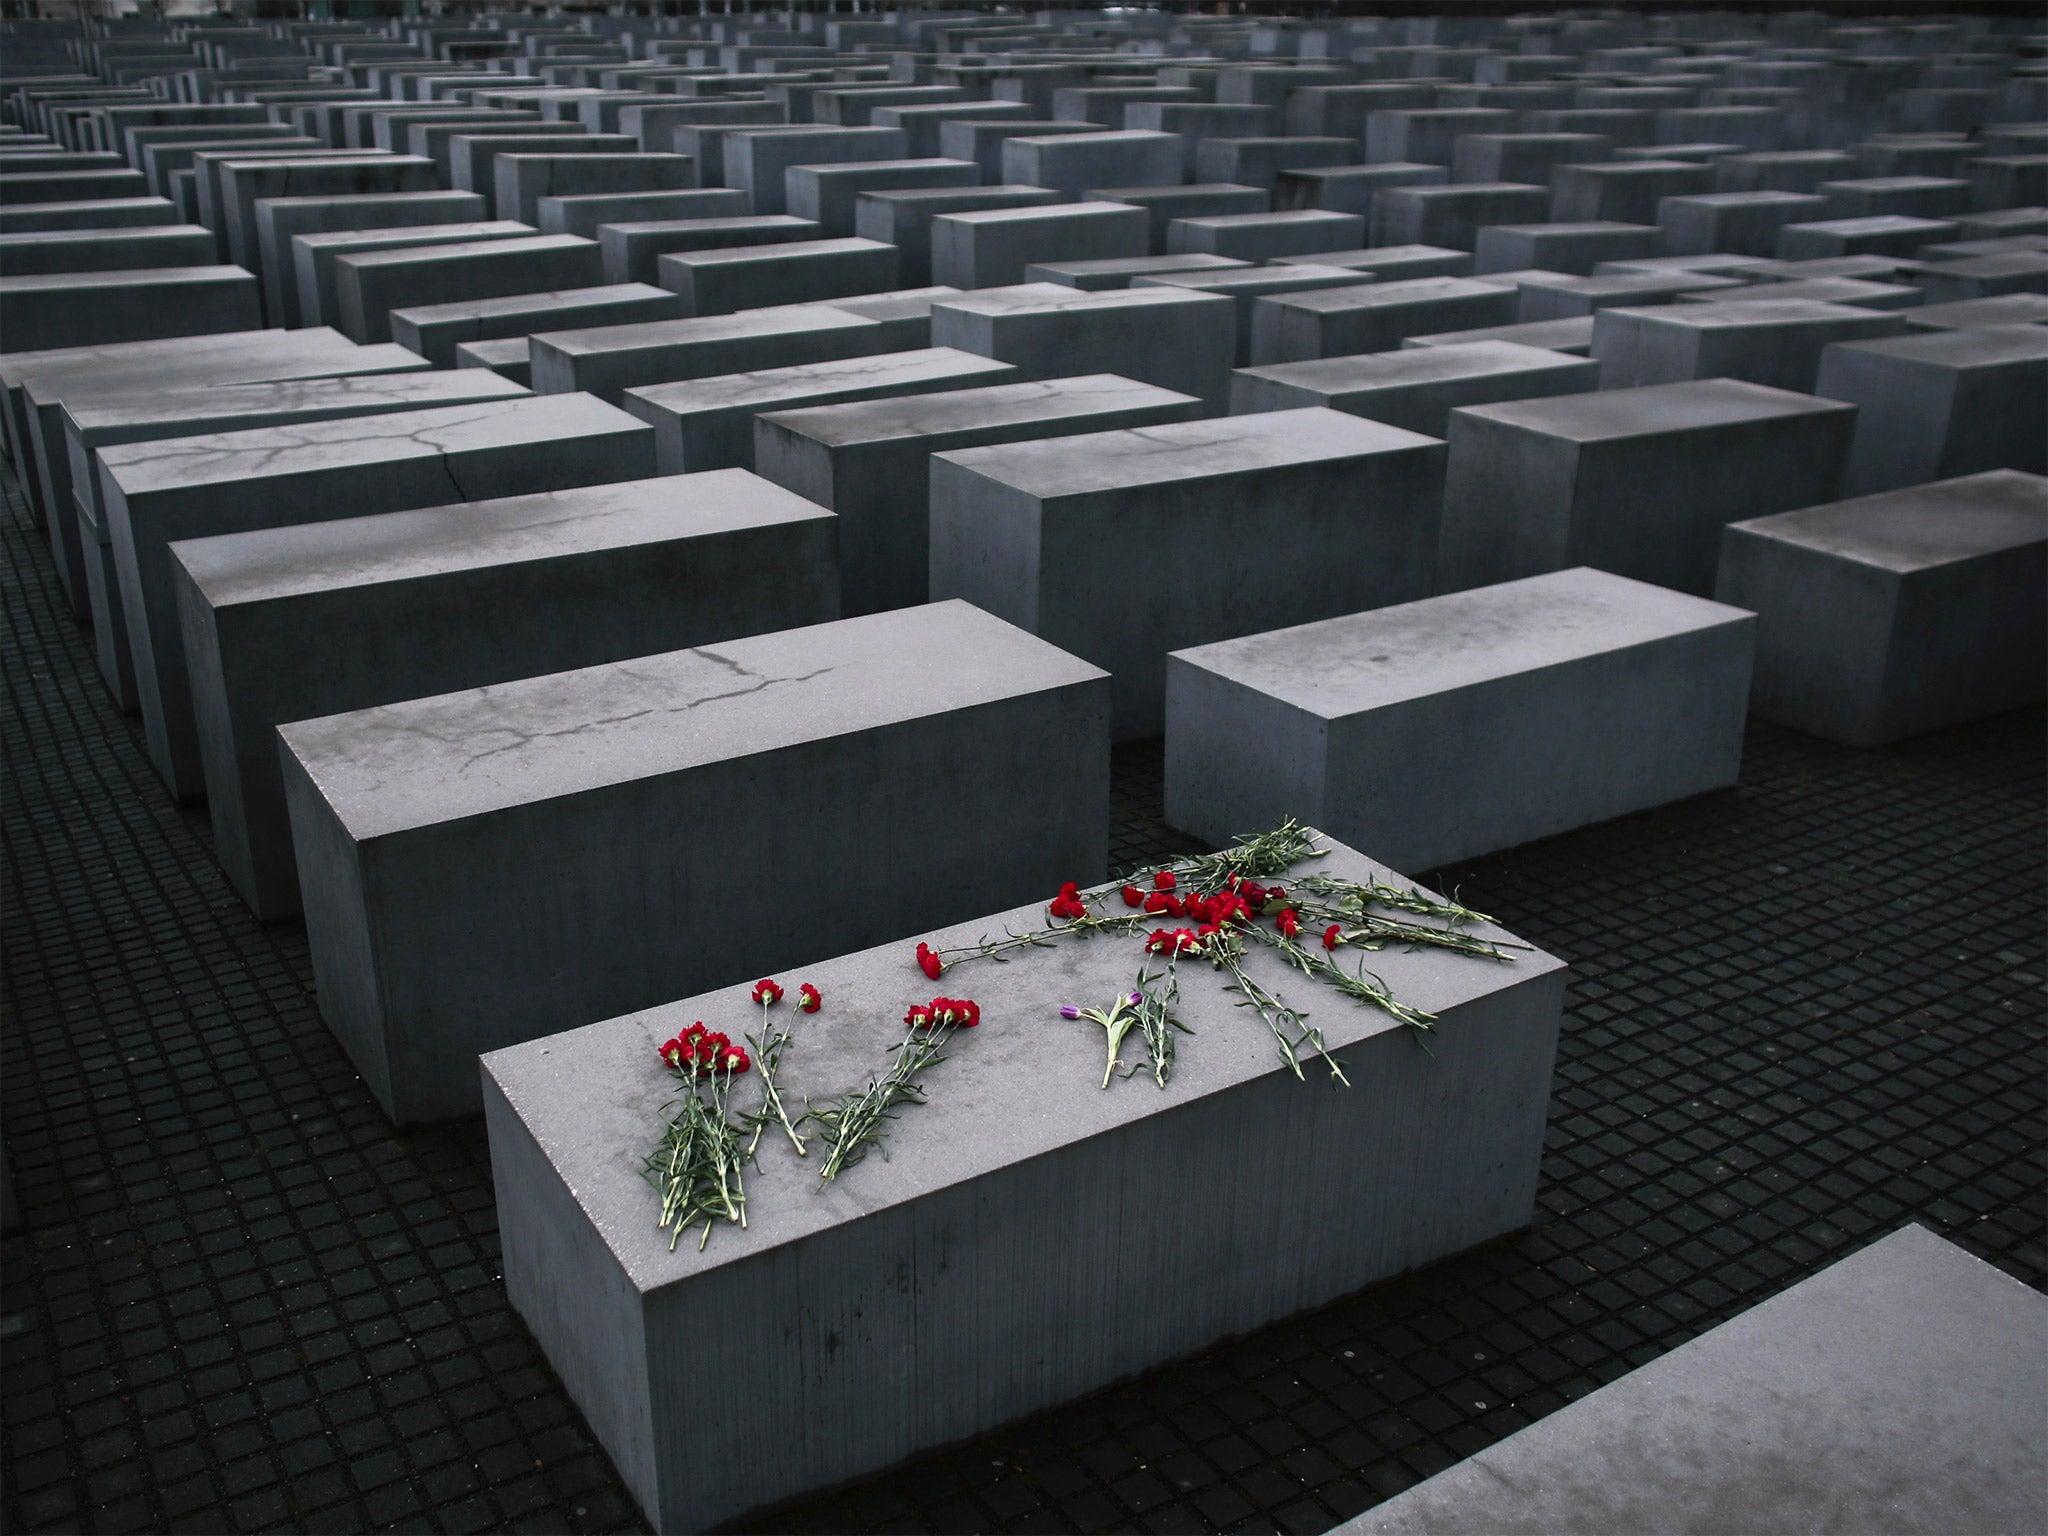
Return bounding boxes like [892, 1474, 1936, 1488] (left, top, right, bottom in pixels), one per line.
[0, 460, 2048, 1532]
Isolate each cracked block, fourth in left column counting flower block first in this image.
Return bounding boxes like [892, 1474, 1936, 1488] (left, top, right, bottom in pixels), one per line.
[100, 395, 653, 799]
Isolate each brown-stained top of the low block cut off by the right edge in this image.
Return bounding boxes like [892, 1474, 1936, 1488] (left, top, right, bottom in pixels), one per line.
[1731, 469, 2048, 573]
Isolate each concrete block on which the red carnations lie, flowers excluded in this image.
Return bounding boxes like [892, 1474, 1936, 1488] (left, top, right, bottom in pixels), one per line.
[483, 835, 1565, 1530]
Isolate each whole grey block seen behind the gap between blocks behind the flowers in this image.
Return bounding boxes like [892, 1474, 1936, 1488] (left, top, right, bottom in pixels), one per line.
[932, 410, 1444, 739]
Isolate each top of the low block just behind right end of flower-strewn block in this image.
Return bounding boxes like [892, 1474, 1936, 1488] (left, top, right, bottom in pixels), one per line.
[1174, 565, 1751, 721]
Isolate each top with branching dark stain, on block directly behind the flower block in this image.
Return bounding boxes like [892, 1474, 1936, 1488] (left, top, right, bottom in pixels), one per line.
[281, 600, 1106, 842]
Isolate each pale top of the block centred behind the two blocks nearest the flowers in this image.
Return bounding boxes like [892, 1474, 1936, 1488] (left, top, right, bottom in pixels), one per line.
[942, 406, 1442, 500]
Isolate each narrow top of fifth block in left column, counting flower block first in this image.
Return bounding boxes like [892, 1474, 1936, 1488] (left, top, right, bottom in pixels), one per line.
[63, 369, 528, 446]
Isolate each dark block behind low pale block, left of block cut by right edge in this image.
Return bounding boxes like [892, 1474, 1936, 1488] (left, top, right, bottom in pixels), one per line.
[1438, 379, 1855, 596]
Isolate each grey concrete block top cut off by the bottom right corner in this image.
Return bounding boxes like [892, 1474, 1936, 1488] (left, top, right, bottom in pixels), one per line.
[1335, 1228, 2048, 1536]
